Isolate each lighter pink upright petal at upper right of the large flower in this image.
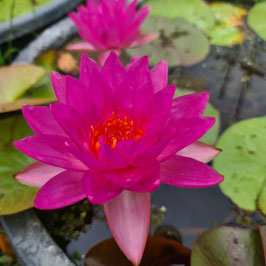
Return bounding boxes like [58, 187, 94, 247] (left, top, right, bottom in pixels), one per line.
[150, 60, 168, 93]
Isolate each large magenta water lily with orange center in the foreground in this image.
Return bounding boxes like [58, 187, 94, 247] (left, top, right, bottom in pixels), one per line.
[14, 52, 223, 265]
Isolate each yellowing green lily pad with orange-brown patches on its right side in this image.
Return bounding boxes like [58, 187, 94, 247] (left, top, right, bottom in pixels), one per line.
[205, 2, 247, 46]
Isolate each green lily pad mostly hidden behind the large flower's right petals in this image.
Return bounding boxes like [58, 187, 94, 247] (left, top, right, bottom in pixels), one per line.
[174, 89, 220, 145]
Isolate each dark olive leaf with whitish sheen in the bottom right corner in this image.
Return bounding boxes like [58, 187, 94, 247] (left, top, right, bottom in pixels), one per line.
[191, 226, 265, 266]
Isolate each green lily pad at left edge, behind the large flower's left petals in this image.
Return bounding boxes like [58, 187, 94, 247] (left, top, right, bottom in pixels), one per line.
[0, 115, 38, 215]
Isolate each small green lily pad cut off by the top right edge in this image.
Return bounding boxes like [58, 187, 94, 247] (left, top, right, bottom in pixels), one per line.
[248, 2, 266, 41]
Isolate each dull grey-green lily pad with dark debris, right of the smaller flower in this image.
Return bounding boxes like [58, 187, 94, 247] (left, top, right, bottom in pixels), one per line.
[127, 17, 209, 67]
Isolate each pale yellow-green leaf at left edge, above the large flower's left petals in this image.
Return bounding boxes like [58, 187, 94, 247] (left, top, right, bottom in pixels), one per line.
[0, 65, 46, 104]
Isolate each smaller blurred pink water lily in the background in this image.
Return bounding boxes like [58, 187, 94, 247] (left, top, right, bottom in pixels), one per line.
[66, 0, 158, 65]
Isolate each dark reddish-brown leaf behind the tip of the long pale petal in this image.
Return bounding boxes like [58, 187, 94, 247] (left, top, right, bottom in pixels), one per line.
[84, 236, 191, 266]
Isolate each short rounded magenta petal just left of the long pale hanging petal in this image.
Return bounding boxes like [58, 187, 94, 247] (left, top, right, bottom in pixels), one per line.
[82, 170, 122, 204]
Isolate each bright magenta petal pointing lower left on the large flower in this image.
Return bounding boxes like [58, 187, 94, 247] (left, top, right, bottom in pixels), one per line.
[34, 171, 86, 210]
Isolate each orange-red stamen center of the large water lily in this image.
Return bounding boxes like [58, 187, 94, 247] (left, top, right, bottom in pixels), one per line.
[90, 112, 143, 154]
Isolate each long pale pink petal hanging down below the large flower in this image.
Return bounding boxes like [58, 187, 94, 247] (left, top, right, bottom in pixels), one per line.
[104, 190, 151, 265]
